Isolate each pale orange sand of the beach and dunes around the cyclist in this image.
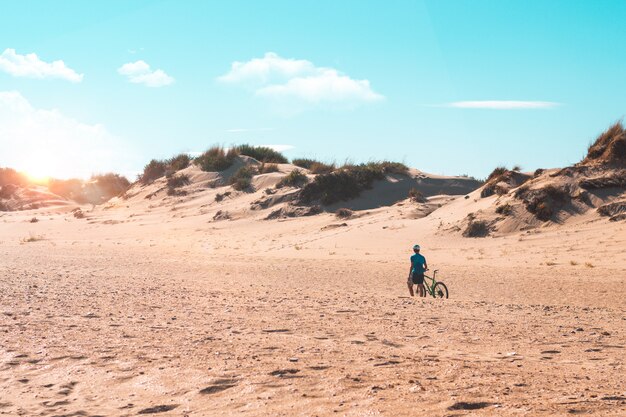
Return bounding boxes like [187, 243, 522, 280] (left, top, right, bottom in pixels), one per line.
[0, 141, 626, 417]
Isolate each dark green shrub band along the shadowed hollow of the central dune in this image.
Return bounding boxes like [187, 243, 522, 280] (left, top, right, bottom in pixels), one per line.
[300, 161, 409, 205]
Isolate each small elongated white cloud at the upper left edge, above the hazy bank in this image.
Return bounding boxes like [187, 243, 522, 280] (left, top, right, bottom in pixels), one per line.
[0, 48, 83, 83]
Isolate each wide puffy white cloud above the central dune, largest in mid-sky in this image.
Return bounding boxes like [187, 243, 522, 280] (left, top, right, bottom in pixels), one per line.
[218, 52, 384, 107]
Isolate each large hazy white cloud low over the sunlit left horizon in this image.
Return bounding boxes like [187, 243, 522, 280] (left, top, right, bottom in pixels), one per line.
[0, 91, 136, 178]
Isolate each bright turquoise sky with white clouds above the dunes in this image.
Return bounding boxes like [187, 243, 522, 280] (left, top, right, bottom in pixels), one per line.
[0, 0, 626, 177]
